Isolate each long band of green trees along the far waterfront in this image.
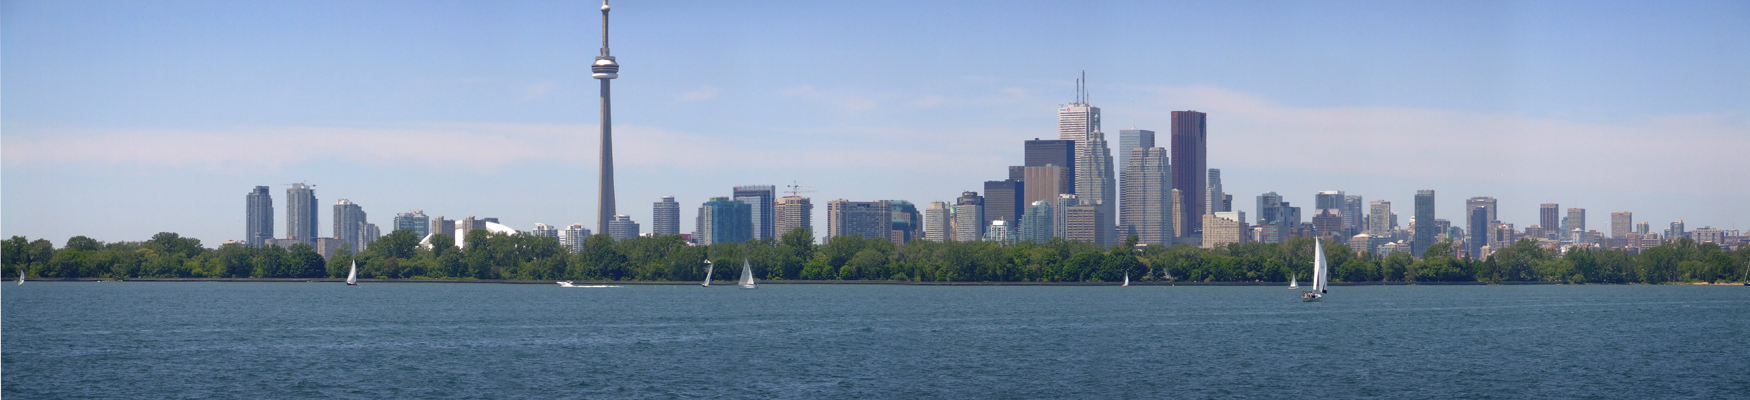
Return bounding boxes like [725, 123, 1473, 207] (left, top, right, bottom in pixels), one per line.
[0, 229, 1750, 283]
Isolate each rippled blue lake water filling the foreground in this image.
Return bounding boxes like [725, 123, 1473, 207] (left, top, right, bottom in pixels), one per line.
[0, 281, 1750, 400]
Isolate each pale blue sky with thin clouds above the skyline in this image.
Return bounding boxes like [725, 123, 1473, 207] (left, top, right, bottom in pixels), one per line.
[0, 0, 1750, 246]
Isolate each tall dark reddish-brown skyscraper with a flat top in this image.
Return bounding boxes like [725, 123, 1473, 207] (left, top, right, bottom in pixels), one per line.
[1173, 112, 1209, 236]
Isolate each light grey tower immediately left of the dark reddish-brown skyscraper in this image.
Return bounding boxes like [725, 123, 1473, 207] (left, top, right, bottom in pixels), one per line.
[1120, 147, 1174, 246]
